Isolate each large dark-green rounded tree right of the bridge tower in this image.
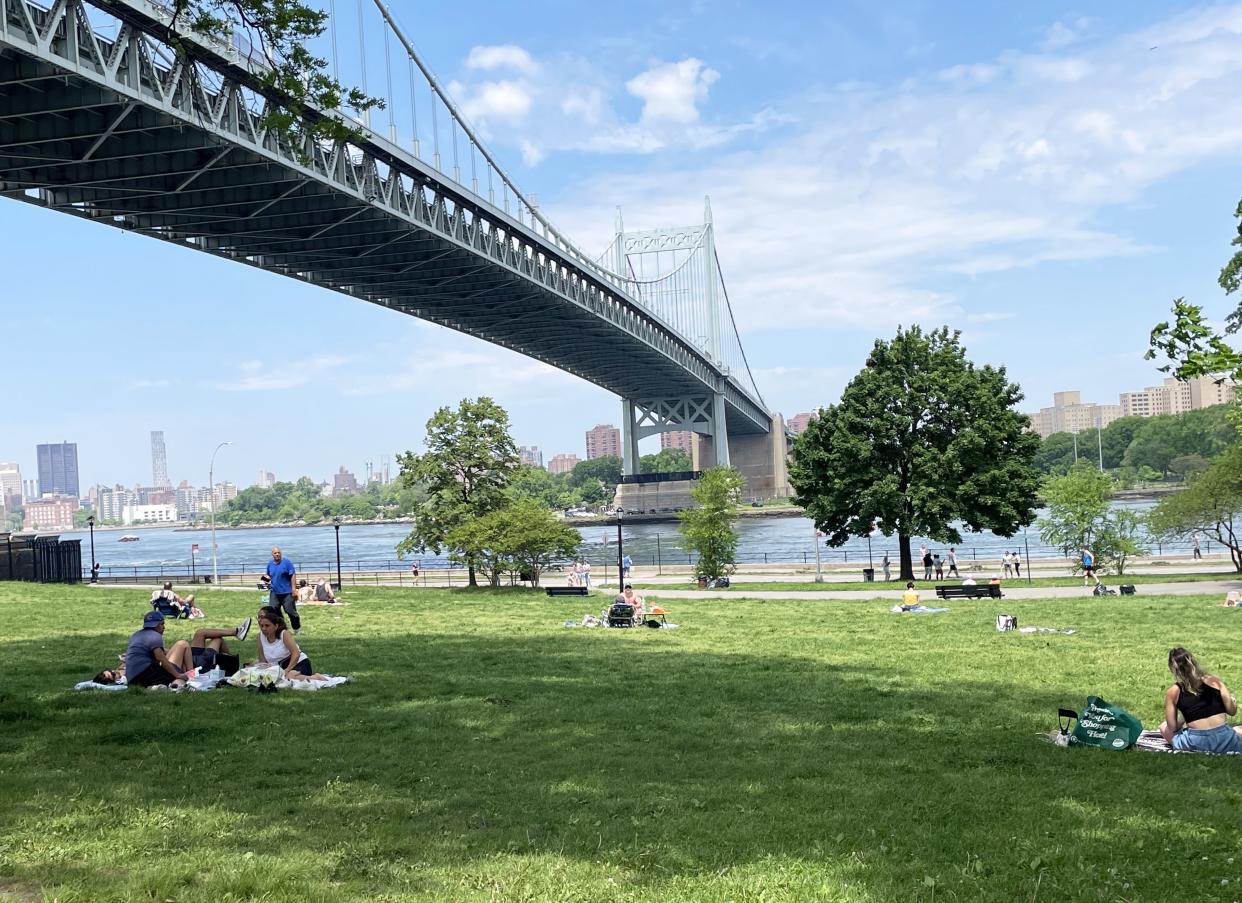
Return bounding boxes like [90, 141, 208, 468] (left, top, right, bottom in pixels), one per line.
[790, 327, 1040, 580]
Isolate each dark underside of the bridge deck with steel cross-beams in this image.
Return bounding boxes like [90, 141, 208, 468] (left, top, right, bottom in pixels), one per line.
[0, 47, 766, 433]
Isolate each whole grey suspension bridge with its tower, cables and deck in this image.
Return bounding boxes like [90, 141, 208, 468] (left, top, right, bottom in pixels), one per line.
[0, 0, 785, 488]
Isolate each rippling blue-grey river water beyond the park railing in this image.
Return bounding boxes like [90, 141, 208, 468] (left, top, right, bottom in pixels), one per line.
[55, 501, 1182, 575]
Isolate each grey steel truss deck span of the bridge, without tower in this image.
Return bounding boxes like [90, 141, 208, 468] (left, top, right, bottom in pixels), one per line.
[0, 0, 771, 446]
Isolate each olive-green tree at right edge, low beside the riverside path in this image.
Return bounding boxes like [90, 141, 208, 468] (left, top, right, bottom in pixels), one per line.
[1149, 446, 1242, 571]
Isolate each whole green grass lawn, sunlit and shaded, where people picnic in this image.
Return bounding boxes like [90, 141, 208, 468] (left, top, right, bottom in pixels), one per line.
[0, 584, 1242, 903]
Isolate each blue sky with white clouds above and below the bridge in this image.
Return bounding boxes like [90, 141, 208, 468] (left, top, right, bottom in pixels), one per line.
[0, 0, 1242, 494]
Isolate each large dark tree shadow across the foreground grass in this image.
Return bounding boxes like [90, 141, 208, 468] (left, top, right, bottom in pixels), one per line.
[0, 619, 1242, 899]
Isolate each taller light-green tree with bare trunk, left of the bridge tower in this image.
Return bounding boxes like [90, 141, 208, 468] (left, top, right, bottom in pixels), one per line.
[397, 396, 519, 586]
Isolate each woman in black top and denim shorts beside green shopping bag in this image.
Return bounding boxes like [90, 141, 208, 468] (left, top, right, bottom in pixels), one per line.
[1160, 646, 1242, 753]
